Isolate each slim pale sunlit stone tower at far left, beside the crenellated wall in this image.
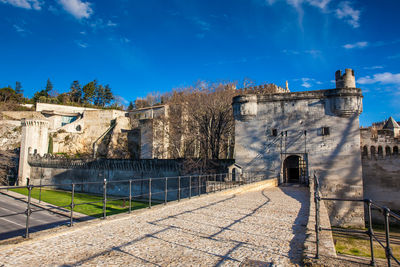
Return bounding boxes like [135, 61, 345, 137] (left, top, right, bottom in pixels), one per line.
[18, 119, 49, 185]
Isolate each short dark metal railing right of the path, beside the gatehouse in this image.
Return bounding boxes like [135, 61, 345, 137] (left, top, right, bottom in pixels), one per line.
[314, 173, 400, 267]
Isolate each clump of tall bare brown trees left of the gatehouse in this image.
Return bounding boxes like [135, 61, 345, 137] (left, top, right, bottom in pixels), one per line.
[162, 83, 238, 162]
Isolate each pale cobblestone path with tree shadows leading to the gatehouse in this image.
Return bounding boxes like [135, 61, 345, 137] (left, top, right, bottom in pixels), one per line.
[0, 187, 309, 266]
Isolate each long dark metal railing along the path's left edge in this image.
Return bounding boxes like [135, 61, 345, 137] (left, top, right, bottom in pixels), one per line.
[0, 172, 270, 238]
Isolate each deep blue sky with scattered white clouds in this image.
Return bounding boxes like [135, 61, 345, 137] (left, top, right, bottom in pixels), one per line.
[0, 0, 400, 126]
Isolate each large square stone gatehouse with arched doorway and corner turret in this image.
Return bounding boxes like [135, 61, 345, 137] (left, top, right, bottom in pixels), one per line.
[233, 69, 363, 226]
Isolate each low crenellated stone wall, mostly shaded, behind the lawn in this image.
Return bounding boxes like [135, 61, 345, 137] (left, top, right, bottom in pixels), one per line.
[25, 155, 232, 200]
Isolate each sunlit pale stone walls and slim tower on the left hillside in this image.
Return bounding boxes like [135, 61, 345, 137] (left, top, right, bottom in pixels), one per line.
[15, 103, 168, 185]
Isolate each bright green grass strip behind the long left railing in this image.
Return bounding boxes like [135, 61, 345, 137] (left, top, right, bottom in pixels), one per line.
[11, 188, 151, 217]
